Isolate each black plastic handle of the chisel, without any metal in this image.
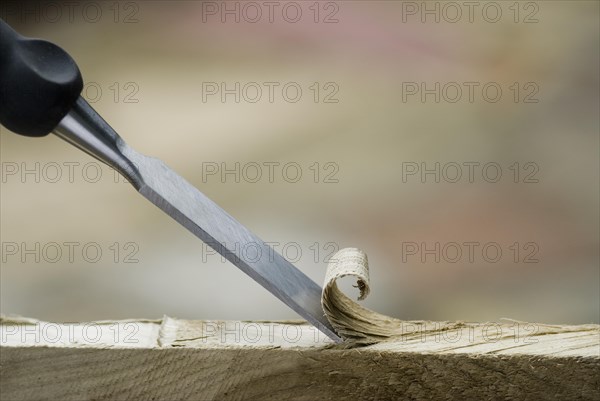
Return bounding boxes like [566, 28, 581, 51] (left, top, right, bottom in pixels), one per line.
[0, 19, 83, 137]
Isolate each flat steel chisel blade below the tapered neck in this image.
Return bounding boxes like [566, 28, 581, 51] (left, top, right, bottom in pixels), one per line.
[121, 145, 341, 342]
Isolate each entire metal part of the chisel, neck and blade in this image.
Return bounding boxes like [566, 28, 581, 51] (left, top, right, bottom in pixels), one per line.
[54, 97, 341, 342]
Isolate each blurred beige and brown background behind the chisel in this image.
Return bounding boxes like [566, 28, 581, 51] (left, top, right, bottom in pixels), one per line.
[0, 1, 600, 323]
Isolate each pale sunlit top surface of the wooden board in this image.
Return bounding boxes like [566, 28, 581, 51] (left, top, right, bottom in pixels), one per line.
[0, 316, 600, 359]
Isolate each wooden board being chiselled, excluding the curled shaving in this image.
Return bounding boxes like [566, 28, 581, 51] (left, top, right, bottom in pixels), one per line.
[0, 317, 600, 400]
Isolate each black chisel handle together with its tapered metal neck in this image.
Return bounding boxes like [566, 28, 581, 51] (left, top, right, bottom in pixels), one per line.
[0, 19, 141, 188]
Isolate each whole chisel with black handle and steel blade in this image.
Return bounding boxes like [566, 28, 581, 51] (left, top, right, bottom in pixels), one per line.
[0, 20, 341, 342]
